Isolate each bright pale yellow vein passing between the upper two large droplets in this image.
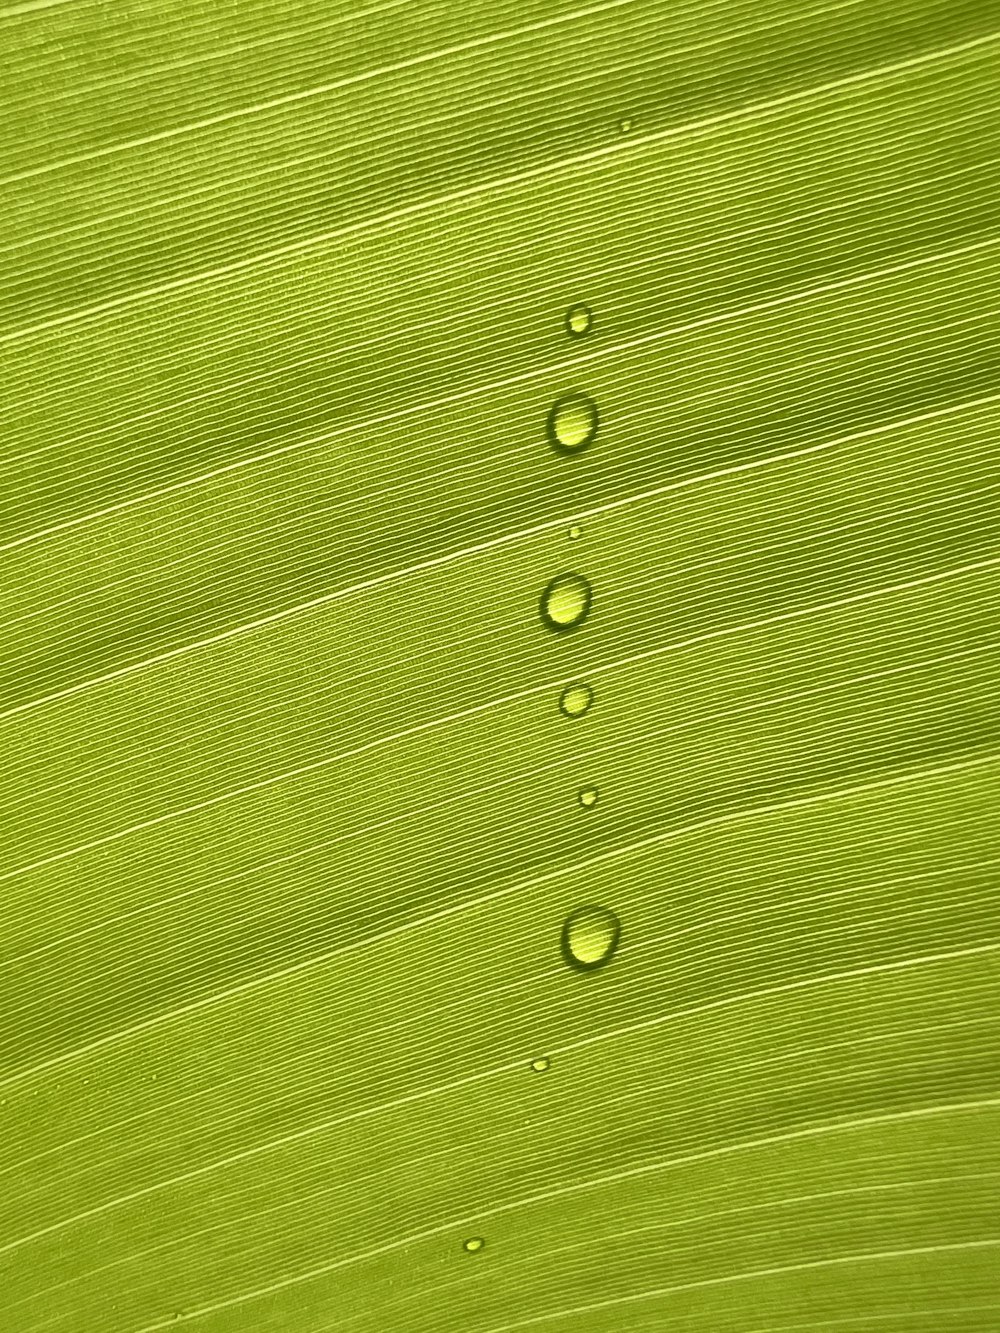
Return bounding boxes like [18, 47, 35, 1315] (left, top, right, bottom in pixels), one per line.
[0, 375, 1000, 722]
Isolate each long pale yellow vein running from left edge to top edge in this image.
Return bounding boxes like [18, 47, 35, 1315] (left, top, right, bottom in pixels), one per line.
[0, 0, 642, 188]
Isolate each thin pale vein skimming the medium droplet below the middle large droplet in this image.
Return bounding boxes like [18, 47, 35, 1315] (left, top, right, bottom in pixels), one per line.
[0, 556, 1000, 882]
